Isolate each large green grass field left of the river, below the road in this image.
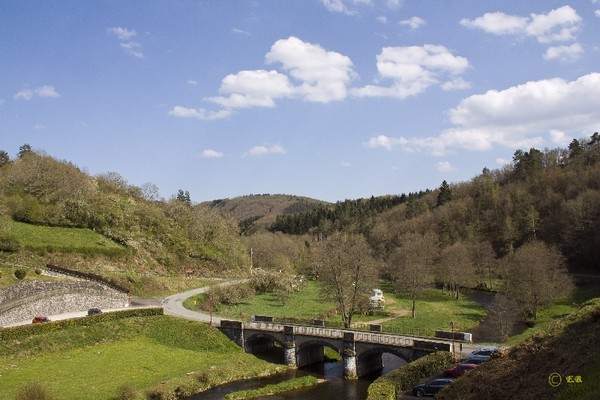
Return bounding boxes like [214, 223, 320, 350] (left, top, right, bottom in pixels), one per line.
[0, 316, 281, 400]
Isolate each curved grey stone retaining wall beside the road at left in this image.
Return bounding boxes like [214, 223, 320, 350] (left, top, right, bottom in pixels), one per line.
[0, 280, 129, 326]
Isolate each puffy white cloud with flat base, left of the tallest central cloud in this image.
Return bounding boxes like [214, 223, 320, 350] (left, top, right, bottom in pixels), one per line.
[207, 70, 294, 108]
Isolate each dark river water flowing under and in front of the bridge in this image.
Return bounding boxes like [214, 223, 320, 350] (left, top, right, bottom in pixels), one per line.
[186, 354, 406, 400]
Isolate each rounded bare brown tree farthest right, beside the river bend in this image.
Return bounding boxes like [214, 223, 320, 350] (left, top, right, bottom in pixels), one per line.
[504, 242, 573, 320]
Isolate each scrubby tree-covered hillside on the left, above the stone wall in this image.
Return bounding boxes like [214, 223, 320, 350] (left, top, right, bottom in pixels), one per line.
[0, 145, 245, 273]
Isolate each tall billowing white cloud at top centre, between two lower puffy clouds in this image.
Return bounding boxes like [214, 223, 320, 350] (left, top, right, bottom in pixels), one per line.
[265, 36, 355, 103]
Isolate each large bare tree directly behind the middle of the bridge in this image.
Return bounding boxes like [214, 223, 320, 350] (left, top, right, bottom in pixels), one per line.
[311, 233, 377, 328]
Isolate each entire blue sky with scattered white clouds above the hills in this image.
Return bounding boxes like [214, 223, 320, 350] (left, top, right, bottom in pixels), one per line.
[0, 0, 600, 202]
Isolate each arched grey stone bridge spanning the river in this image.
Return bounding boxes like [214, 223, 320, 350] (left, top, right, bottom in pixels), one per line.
[220, 320, 453, 379]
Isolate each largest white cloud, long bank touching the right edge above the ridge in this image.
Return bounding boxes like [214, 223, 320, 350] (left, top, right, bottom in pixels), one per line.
[365, 73, 600, 156]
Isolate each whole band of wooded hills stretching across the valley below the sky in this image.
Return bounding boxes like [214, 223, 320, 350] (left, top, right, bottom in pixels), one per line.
[0, 134, 600, 292]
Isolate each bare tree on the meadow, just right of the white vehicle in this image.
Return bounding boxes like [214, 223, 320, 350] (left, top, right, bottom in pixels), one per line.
[390, 233, 438, 318]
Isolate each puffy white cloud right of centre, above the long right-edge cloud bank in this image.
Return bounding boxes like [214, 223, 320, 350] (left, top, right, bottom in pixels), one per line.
[354, 44, 469, 99]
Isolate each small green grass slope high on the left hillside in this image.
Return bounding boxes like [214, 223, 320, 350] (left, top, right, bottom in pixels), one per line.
[10, 221, 126, 256]
